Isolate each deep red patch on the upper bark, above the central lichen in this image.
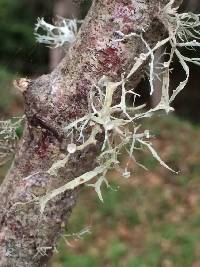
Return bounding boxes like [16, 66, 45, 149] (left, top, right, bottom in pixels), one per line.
[99, 47, 121, 72]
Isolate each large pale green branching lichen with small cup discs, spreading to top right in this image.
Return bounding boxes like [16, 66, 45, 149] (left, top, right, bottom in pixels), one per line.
[36, 0, 200, 212]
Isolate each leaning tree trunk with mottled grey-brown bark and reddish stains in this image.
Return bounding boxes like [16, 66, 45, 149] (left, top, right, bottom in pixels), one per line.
[0, 0, 180, 267]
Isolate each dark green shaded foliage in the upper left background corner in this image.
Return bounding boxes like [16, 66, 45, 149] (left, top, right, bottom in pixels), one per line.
[0, 0, 53, 75]
